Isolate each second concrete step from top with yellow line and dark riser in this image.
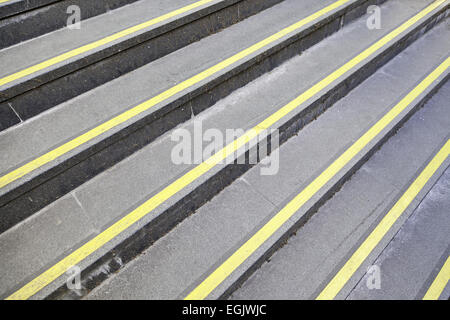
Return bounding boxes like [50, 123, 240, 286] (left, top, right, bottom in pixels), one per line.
[0, 0, 406, 231]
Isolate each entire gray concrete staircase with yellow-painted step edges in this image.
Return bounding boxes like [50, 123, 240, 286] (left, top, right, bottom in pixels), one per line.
[0, 0, 450, 299]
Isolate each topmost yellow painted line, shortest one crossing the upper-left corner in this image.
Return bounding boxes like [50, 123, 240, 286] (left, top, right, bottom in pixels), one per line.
[0, 0, 214, 86]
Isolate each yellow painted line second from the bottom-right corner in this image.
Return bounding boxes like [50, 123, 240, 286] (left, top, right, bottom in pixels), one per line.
[317, 140, 450, 300]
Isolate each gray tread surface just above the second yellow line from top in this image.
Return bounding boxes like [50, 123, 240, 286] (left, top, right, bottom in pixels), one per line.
[0, 0, 342, 178]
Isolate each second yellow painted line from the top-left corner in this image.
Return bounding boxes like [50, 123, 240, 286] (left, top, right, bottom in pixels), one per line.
[0, 0, 358, 189]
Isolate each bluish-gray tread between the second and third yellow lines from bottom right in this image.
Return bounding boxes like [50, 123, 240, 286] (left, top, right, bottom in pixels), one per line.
[231, 83, 450, 299]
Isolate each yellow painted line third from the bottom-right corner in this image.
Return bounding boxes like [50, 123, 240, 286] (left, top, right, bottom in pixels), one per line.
[185, 62, 450, 300]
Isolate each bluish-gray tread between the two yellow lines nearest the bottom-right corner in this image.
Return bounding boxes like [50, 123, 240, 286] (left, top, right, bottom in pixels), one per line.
[348, 162, 450, 300]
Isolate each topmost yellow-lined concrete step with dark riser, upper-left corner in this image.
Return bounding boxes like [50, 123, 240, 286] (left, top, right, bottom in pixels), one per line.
[0, 0, 281, 130]
